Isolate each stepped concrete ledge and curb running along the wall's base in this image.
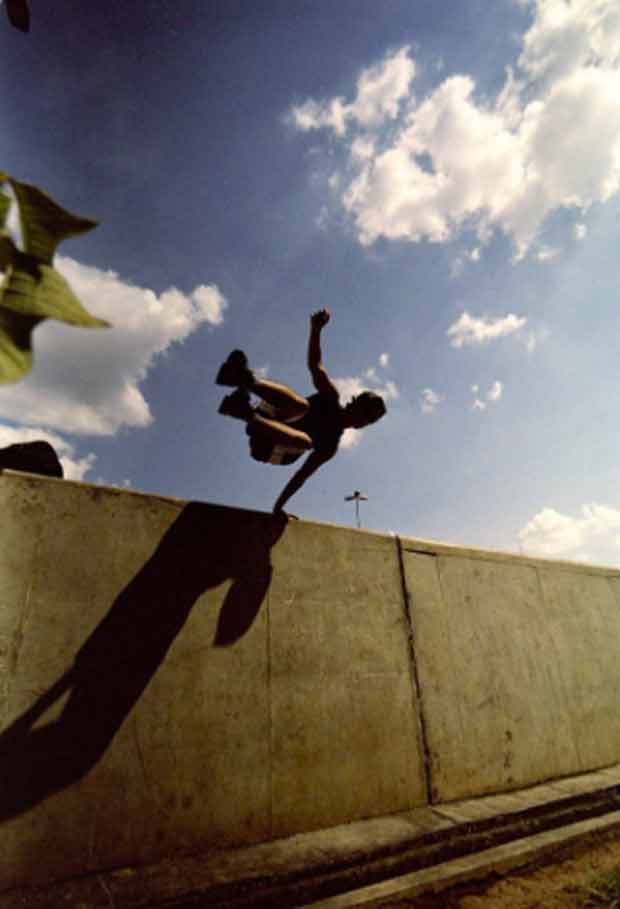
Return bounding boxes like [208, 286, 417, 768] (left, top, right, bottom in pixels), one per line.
[0, 765, 620, 909]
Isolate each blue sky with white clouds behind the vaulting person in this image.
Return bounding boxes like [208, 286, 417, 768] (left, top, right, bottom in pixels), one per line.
[0, 0, 620, 564]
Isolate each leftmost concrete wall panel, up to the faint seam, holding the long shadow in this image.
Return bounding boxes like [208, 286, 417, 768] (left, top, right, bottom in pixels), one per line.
[0, 474, 271, 887]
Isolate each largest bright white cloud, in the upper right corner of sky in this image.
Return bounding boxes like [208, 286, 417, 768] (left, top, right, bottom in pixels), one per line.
[294, 0, 620, 255]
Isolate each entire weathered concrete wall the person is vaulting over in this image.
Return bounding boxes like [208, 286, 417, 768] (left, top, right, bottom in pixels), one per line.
[0, 473, 620, 889]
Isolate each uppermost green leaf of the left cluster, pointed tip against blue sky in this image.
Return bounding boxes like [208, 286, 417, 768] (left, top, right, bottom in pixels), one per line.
[9, 178, 99, 265]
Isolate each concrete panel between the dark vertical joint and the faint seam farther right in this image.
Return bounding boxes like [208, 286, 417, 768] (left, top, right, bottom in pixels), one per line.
[405, 553, 575, 801]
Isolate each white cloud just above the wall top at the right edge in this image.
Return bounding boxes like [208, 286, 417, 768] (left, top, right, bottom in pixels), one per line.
[518, 504, 620, 565]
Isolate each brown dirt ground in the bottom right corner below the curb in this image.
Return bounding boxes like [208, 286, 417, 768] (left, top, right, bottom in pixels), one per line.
[372, 832, 620, 909]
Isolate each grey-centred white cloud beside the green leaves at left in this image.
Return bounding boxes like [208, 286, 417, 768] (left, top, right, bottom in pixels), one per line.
[0, 257, 228, 435]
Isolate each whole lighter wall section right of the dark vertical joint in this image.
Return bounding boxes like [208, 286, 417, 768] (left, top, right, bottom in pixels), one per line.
[403, 540, 620, 802]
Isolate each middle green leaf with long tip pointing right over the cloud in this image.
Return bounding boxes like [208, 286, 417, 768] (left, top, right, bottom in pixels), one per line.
[0, 260, 109, 328]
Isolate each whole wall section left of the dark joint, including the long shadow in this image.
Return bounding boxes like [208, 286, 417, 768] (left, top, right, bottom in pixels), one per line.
[0, 473, 426, 889]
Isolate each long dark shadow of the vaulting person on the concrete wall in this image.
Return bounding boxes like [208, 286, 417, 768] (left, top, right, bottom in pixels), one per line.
[0, 502, 286, 821]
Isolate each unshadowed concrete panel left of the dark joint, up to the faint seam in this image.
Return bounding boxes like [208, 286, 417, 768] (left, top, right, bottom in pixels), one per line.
[269, 523, 426, 835]
